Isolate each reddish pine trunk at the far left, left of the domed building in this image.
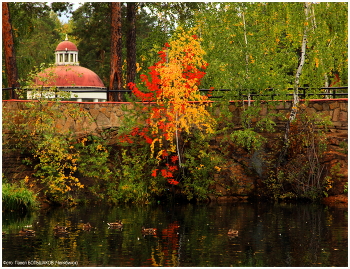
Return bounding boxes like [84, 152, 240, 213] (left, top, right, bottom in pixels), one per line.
[2, 2, 20, 99]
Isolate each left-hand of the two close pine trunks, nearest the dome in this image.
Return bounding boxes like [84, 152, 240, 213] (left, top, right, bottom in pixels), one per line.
[108, 2, 123, 101]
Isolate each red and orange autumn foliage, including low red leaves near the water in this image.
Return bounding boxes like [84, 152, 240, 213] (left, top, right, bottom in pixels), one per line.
[122, 29, 208, 185]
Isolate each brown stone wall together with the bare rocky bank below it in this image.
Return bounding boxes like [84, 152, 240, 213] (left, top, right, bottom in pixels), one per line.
[2, 99, 348, 199]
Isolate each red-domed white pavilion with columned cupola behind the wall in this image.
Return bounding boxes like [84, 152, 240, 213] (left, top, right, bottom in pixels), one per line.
[35, 36, 107, 102]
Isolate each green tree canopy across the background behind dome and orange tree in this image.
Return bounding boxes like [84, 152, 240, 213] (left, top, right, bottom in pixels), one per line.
[3, 2, 348, 90]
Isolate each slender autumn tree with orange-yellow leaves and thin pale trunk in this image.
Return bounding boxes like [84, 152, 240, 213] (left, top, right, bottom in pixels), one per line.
[129, 28, 215, 182]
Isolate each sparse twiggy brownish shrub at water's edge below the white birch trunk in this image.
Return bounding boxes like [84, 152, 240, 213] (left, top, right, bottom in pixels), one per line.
[264, 111, 333, 200]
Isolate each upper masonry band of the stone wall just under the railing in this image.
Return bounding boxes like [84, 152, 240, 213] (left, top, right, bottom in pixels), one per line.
[2, 99, 348, 136]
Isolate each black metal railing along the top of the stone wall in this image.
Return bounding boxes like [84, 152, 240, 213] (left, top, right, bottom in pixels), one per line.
[2, 86, 348, 101]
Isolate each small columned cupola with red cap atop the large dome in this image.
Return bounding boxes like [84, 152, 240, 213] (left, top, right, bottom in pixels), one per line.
[55, 34, 79, 65]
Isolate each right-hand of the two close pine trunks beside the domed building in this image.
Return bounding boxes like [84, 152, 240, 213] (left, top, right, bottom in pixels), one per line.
[126, 2, 136, 91]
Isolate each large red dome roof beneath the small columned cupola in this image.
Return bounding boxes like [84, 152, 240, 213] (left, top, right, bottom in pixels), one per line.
[34, 65, 104, 88]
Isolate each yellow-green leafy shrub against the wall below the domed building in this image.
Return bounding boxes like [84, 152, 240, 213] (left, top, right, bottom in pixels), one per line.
[3, 66, 90, 204]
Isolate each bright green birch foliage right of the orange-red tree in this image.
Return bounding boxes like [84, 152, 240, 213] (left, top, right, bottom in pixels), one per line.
[196, 2, 348, 91]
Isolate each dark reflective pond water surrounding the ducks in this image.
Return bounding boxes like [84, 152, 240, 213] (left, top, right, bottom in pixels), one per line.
[2, 202, 348, 267]
